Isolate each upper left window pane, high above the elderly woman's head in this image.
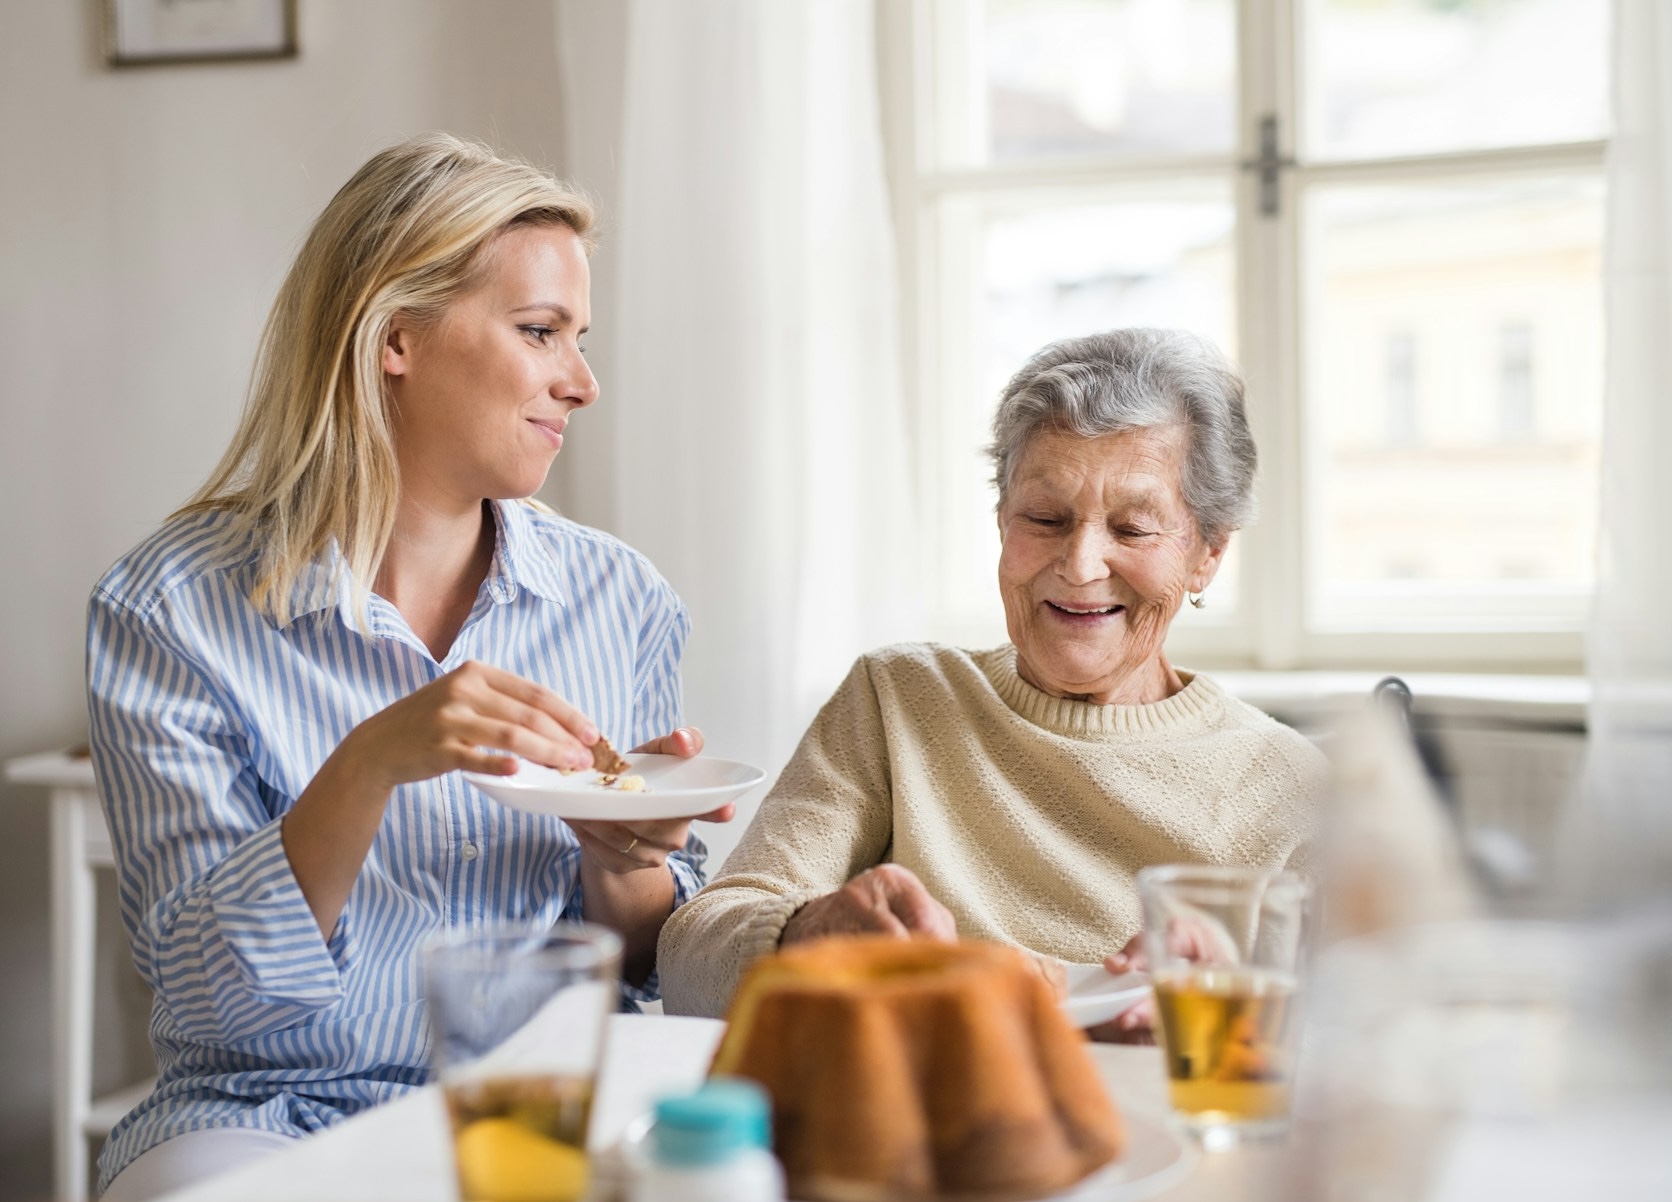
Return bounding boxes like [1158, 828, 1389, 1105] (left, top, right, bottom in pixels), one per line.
[963, 0, 1236, 162]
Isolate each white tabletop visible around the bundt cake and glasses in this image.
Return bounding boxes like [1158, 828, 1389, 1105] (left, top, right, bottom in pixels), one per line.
[159, 1015, 1276, 1202]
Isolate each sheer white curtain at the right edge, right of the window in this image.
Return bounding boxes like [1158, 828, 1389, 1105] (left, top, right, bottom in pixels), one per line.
[1570, 0, 1672, 901]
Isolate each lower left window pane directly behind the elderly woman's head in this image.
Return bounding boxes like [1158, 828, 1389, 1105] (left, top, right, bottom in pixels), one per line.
[938, 181, 1237, 632]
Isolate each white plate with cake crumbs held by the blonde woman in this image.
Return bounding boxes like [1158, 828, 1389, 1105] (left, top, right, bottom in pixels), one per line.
[465, 752, 766, 823]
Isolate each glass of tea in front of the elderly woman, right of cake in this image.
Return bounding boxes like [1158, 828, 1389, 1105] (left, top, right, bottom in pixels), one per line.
[1139, 864, 1313, 1147]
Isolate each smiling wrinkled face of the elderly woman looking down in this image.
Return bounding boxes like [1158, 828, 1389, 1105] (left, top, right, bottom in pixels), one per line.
[998, 428, 1224, 704]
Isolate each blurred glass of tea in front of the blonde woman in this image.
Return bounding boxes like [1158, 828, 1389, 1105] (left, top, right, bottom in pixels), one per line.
[423, 923, 622, 1202]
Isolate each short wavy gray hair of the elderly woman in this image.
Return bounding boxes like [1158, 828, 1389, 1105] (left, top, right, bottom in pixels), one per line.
[986, 329, 1256, 543]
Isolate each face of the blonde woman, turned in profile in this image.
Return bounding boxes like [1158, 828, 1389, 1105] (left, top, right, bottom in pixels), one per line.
[383, 226, 599, 512]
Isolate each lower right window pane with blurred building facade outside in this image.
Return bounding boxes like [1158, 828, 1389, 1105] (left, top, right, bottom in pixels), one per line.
[1304, 176, 1602, 629]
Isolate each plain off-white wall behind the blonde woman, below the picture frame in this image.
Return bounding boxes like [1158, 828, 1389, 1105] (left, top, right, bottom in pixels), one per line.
[0, 0, 580, 1199]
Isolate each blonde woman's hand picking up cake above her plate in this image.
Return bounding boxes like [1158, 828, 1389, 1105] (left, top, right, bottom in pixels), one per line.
[333, 662, 599, 791]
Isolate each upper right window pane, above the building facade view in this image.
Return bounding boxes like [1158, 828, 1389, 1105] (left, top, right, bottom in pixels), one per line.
[1304, 0, 1608, 159]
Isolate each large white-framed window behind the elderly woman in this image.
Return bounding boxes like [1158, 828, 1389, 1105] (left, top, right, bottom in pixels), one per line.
[881, 0, 1608, 669]
